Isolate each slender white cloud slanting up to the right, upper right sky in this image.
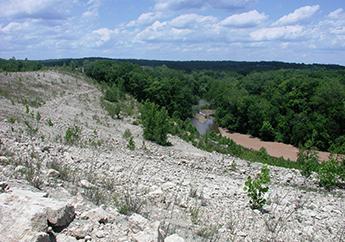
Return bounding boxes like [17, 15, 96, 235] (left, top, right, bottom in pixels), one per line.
[273, 5, 320, 25]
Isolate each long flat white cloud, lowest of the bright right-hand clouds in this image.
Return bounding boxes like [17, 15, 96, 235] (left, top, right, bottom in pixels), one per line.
[250, 25, 304, 41]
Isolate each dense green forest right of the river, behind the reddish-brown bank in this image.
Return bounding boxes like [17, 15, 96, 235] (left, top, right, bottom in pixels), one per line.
[207, 69, 345, 153]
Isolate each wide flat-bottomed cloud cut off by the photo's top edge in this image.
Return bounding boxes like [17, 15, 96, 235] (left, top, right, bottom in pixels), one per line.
[155, 0, 255, 11]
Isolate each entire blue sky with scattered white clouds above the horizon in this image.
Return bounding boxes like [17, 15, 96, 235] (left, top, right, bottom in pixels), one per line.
[0, 0, 345, 65]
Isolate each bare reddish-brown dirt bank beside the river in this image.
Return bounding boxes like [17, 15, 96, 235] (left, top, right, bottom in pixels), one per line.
[219, 128, 330, 161]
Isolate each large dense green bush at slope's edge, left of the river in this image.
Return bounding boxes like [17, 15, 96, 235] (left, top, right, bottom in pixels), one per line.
[140, 102, 169, 145]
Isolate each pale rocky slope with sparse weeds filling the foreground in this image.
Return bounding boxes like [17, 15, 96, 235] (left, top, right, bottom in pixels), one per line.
[0, 71, 345, 242]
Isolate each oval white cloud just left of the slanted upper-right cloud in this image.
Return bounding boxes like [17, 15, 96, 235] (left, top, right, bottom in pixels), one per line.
[220, 10, 268, 27]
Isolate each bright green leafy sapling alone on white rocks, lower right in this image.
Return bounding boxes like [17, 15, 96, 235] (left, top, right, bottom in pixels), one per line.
[244, 165, 270, 209]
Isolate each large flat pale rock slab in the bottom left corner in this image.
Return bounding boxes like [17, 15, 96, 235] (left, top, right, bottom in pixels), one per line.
[0, 188, 75, 242]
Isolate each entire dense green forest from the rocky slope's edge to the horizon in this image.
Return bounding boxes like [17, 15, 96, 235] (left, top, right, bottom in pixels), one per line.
[0, 58, 345, 153]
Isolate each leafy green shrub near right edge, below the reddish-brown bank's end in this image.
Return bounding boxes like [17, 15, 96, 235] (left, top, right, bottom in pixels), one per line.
[319, 159, 340, 190]
